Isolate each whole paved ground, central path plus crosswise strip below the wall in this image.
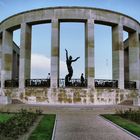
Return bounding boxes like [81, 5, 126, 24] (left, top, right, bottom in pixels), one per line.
[1, 105, 136, 140]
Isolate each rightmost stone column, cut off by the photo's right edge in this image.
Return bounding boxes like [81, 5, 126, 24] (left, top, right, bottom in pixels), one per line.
[129, 32, 140, 89]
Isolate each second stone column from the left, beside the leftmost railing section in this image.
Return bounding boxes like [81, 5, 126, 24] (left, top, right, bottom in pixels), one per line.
[19, 23, 32, 90]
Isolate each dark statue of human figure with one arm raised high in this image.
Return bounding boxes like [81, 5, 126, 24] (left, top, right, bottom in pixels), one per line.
[65, 49, 80, 85]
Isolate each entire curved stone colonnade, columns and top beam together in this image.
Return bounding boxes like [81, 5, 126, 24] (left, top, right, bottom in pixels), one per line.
[0, 7, 140, 95]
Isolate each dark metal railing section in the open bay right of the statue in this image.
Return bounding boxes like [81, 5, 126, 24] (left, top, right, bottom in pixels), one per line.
[94, 79, 118, 88]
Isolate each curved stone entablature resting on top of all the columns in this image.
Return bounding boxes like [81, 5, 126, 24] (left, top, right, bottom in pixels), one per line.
[0, 7, 140, 33]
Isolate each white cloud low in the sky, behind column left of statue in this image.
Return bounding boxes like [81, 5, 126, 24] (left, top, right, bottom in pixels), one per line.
[31, 54, 67, 78]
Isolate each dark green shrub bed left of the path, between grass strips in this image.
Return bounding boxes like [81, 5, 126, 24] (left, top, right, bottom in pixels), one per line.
[0, 109, 41, 139]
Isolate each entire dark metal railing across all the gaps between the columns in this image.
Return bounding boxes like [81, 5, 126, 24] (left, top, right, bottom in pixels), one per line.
[5, 79, 136, 89]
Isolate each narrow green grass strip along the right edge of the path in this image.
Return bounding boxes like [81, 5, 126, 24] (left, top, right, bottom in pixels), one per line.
[102, 114, 140, 137]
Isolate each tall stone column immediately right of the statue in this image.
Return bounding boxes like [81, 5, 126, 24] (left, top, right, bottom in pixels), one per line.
[85, 19, 95, 88]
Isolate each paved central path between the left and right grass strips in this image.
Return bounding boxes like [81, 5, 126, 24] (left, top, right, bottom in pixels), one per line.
[54, 106, 136, 140]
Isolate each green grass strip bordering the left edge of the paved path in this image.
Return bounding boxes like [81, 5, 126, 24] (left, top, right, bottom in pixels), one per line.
[28, 114, 56, 140]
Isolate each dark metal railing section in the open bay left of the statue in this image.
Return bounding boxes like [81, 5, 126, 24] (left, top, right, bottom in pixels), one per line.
[25, 79, 50, 87]
